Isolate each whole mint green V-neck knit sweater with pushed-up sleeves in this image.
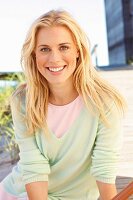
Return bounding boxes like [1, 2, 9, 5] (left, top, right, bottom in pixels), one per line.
[2, 93, 122, 200]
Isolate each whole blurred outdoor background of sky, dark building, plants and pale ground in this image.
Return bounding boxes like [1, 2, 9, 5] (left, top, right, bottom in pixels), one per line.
[0, 0, 133, 199]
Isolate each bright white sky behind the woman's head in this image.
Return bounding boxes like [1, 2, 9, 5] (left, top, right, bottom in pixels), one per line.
[0, 0, 108, 72]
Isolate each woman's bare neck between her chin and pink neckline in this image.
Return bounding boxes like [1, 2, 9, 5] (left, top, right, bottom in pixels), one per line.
[49, 83, 78, 105]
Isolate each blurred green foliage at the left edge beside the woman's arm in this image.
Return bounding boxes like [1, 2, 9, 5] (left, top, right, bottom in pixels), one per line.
[0, 73, 24, 162]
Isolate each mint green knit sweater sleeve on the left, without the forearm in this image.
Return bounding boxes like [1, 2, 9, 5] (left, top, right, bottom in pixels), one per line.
[11, 91, 50, 184]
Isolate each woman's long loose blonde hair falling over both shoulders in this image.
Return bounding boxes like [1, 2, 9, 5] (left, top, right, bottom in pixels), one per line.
[11, 10, 125, 133]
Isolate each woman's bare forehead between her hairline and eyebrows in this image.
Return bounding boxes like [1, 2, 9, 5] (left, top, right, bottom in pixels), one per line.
[36, 26, 74, 43]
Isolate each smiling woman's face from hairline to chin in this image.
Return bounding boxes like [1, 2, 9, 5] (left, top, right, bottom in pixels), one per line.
[35, 26, 79, 85]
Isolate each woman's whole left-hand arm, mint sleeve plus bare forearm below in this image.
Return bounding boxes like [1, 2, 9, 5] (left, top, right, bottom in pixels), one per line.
[11, 91, 50, 196]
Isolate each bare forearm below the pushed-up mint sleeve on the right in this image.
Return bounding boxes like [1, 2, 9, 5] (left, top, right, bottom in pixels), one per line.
[97, 181, 117, 200]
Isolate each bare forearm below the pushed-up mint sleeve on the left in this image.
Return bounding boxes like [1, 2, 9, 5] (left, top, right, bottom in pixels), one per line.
[25, 181, 48, 200]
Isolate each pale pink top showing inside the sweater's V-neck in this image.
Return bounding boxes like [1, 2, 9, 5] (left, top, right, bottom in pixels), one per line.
[47, 96, 83, 138]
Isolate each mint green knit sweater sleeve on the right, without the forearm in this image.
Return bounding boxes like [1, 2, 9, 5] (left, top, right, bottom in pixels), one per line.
[90, 103, 122, 184]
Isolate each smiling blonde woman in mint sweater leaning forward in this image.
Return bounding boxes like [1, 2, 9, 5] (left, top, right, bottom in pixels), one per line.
[0, 10, 125, 200]
